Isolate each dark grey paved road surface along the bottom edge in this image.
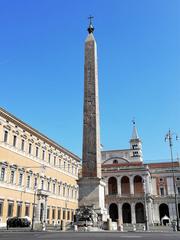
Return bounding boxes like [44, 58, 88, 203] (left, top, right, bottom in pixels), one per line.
[0, 232, 180, 240]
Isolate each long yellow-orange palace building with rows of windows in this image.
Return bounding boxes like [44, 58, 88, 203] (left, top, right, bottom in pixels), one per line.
[0, 108, 80, 227]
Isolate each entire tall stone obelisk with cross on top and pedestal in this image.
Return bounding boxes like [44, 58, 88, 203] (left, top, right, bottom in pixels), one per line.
[76, 17, 108, 230]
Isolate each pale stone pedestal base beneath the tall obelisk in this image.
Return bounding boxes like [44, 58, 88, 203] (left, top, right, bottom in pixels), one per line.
[76, 177, 109, 231]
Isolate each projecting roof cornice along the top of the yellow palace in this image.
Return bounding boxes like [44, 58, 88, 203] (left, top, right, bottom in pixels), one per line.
[0, 107, 81, 162]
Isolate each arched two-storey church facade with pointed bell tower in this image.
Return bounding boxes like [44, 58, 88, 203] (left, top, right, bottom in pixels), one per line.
[102, 125, 180, 227]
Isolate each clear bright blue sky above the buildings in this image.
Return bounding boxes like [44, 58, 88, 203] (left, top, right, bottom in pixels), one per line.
[0, 0, 180, 162]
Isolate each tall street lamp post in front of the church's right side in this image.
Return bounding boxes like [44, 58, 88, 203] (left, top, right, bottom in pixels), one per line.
[165, 129, 180, 231]
